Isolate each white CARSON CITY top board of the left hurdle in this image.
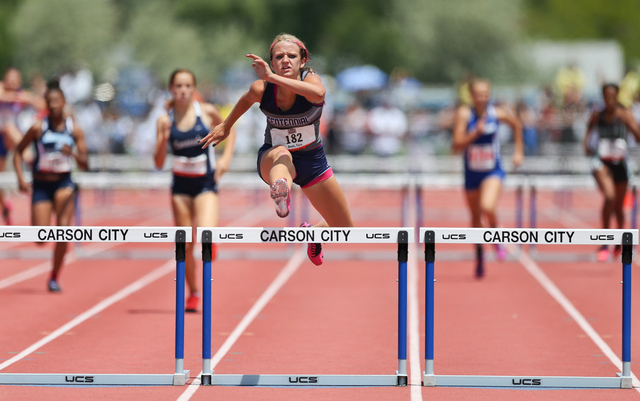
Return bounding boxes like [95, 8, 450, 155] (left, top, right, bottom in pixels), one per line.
[0, 226, 193, 242]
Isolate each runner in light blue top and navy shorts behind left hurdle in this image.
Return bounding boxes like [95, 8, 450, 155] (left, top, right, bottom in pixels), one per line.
[13, 82, 88, 292]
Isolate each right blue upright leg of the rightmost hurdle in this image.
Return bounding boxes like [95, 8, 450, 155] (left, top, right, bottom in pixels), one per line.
[620, 233, 633, 388]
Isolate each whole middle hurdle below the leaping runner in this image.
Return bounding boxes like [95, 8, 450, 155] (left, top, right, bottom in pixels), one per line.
[197, 227, 414, 387]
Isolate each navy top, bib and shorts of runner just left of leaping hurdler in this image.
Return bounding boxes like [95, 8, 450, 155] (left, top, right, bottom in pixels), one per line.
[169, 102, 218, 197]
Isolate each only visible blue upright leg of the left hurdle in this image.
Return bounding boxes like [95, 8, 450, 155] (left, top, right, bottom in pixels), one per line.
[173, 230, 189, 386]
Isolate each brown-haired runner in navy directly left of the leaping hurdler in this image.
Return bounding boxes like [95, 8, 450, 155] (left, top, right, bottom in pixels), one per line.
[153, 69, 235, 312]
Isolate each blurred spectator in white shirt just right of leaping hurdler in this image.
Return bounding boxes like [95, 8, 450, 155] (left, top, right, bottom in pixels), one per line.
[368, 98, 408, 156]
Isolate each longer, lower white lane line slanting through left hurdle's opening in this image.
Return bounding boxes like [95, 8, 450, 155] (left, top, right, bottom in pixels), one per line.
[0, 260, 176, 370]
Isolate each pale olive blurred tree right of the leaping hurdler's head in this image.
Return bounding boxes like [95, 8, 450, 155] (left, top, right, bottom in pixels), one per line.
[394, 0, 525, 83]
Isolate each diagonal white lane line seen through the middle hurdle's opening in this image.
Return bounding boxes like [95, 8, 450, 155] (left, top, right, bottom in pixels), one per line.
[178, 248, 306, 401]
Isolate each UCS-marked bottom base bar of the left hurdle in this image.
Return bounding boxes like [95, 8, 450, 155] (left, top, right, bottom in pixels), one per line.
[0, 370, 189, 387]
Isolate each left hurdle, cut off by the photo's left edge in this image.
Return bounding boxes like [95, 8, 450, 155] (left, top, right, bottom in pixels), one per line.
[0, 226, 193, 386]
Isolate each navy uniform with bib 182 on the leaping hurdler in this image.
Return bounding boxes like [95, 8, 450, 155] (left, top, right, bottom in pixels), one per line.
[258, 71, 333, 188]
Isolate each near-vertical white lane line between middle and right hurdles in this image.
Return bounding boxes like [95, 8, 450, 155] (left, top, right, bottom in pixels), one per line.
[407, 239, 422, 401]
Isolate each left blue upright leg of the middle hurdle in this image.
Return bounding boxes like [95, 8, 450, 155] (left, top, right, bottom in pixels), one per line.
[201, 230, 213, 386]
